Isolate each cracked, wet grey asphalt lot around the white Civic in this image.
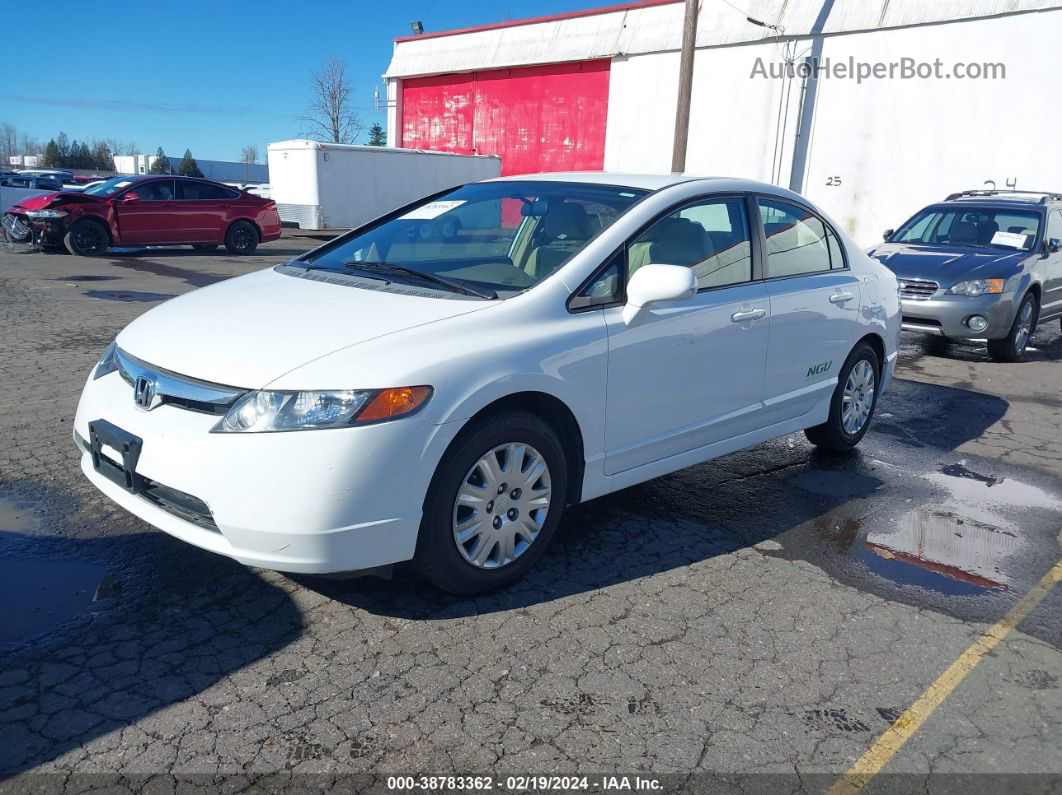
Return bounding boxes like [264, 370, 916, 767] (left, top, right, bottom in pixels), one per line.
[0, 231, 1062, 792]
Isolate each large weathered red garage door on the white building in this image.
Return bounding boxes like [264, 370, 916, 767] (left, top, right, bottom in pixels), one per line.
[400, 58, 610, 174]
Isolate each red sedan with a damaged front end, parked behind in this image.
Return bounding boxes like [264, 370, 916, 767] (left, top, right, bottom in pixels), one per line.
[5, 175, 280, 257]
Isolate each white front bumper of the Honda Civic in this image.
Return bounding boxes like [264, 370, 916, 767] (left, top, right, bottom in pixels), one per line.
[74, 373, 450, 573]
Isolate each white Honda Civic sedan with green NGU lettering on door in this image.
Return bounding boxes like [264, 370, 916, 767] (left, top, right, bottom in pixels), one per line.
[74, 173, 901, 593]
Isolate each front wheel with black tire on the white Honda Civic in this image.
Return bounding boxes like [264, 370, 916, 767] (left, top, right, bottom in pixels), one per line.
[413, 411, 568, 595]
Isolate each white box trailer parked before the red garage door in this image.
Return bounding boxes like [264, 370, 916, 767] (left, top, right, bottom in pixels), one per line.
[268, 140, 501, 229]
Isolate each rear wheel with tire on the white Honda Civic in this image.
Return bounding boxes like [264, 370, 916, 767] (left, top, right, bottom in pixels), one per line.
[804, 343, 881, 452]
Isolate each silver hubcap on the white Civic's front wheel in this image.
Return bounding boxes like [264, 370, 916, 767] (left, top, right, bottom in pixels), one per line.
[452, 442, 551, 569]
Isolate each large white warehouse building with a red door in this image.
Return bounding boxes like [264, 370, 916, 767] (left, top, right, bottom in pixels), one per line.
[384, 0, 1062, 244]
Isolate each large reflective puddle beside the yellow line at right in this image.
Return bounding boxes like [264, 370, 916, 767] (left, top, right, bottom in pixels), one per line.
[773, 461, 1062, 612]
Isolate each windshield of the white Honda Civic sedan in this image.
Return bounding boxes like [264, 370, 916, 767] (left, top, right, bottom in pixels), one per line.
[308, 182, 646, 295]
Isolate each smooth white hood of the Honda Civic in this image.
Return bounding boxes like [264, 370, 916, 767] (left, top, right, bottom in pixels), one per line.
[117, 263, 494, 388]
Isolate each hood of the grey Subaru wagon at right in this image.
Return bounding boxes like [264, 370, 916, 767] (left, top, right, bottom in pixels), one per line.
[868, 243, 1029, 287]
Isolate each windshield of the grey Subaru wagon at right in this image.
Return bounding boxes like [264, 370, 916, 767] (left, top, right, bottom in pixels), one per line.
[889, 207, 1040, 252]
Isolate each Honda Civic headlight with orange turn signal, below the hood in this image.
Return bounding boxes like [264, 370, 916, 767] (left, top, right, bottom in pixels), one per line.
[212, 386, 431, 433]
